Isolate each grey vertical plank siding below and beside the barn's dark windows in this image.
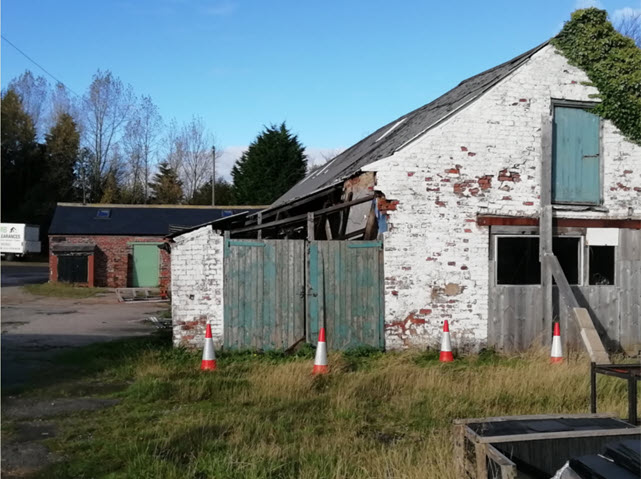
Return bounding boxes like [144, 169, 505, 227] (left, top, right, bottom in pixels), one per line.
[488, 229, 641, 354]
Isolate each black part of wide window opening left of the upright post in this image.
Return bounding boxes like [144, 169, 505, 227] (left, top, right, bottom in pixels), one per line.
[496, 236, 541, 284]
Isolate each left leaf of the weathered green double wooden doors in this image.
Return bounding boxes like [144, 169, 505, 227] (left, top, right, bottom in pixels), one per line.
[223, 240, 305, 350]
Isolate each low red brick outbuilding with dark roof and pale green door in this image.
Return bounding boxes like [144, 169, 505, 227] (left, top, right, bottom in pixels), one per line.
[49, 203, 262, 288]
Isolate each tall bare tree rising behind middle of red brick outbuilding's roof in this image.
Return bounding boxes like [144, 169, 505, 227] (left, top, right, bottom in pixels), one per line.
[83, 70, 135, 199]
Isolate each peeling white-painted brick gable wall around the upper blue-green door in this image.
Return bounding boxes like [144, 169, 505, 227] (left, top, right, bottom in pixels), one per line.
[367, 46, 641, 349]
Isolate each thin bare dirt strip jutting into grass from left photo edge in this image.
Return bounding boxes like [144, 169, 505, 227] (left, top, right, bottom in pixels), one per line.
[2, 398, 120, 419]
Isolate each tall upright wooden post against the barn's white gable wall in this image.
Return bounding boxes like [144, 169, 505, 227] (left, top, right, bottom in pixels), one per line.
[539, 114, 560, 345]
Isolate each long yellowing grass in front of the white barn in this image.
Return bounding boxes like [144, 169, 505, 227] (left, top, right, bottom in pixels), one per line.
[7, 336, 627, 479]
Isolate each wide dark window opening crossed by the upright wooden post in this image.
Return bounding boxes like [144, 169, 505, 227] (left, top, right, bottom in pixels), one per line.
[495, 235, 583, 285]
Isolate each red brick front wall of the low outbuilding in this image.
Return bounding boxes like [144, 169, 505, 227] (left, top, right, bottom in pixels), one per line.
[49, 235, 171, 288]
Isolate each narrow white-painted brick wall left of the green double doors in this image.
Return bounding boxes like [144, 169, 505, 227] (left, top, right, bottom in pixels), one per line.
[171, 226, 224, 348]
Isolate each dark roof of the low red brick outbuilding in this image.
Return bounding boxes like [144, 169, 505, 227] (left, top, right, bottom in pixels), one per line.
[49, 203, 265, 236]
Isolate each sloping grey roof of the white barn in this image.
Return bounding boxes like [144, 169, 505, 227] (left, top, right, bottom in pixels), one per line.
[272, 42, 549, 206]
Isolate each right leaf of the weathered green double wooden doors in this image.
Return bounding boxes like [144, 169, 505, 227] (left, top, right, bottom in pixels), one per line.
[307, 241, 385, 349]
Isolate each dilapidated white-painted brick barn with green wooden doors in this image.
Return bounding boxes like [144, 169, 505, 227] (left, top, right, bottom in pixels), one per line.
[170, 30, 641, 353]
